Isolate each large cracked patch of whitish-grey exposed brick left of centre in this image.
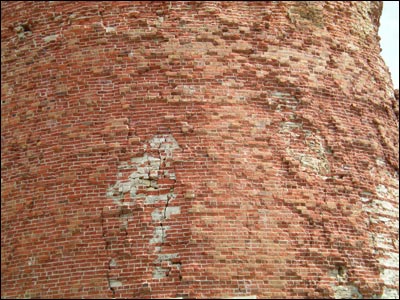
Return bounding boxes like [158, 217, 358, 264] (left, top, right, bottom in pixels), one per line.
[107, 135, 181, 294]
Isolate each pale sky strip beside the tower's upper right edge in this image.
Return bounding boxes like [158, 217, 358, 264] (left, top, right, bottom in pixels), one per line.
[379, 1, 399, 89]
